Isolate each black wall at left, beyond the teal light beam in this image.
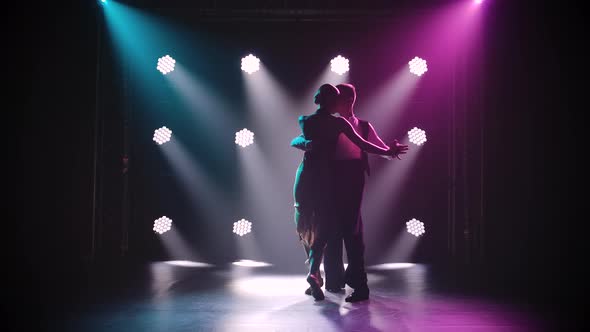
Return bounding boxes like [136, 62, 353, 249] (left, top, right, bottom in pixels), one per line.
[21, 1, 96, 323]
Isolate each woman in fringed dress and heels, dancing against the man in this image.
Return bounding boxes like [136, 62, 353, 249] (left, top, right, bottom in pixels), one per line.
[294, 84, 399, 300]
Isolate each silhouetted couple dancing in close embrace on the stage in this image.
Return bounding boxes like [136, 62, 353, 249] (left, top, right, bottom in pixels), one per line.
[291, 84, 408, 302]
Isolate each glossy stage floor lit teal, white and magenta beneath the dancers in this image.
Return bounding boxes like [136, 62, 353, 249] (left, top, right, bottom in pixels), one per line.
[50, 262, 550, 332]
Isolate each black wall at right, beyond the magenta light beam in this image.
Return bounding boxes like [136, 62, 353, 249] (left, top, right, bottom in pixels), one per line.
[483, 1, 585, 303]
